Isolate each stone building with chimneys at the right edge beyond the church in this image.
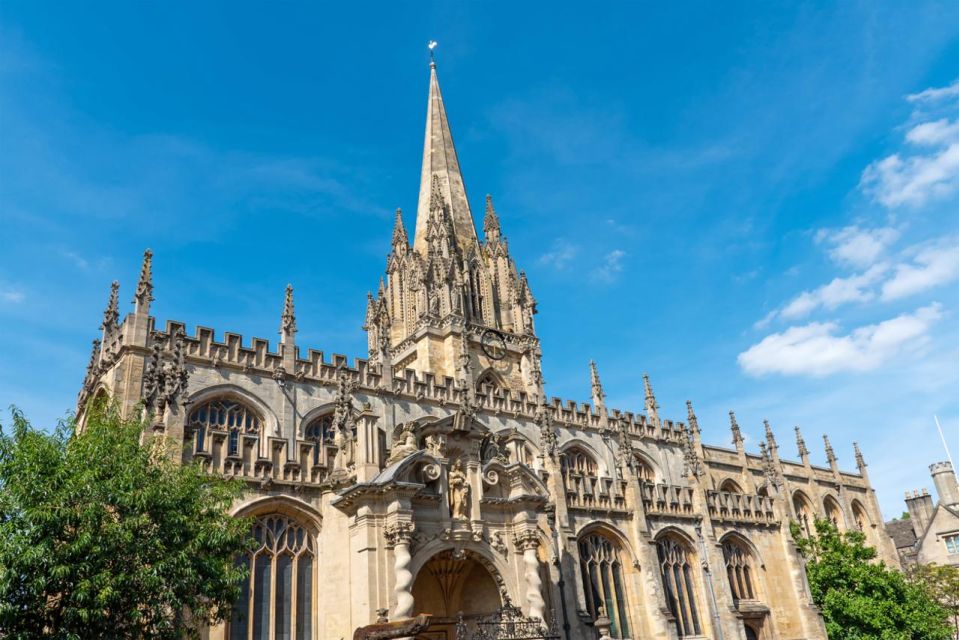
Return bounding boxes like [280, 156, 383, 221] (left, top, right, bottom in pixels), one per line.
[886, 462, 959, 567]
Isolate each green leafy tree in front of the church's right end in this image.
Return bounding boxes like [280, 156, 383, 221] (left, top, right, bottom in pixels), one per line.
[792, 520, 952, 640]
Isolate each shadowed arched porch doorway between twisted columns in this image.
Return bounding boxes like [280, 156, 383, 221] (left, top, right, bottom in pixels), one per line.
[413, 549, 503, 640]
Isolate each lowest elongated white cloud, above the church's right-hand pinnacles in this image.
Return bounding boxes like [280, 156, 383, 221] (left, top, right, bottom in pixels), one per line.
[737, 303, 942, 377]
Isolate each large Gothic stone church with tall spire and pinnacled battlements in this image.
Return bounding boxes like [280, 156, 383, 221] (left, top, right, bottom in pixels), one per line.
[78, 60, 897, 640]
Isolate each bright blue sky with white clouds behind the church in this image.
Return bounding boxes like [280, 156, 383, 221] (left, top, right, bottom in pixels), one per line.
[0, 0, 959, 516]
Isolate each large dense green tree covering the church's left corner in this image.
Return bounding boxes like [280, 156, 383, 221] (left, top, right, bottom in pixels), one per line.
[0, 408, 251, 639]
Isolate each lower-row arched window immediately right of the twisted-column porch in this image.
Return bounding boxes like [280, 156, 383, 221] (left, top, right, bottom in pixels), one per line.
[579, 533, 629, 638]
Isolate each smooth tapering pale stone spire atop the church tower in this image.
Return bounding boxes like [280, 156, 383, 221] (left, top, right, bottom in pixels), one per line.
[413, 63, 479, 256]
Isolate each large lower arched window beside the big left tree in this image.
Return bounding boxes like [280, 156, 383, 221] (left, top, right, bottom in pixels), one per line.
[228, 514, 316, 640]
